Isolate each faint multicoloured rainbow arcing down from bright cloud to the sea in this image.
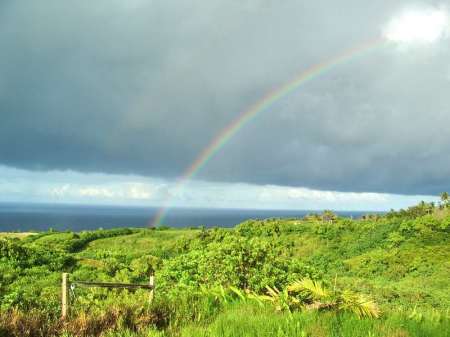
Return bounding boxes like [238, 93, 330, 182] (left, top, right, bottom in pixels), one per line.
[152, 38, 386, 227]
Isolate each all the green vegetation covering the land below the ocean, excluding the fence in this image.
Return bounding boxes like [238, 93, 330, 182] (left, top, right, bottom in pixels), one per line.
[0, 200, 450, 337]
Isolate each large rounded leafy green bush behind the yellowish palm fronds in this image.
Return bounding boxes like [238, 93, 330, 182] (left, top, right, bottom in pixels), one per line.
[158, 234, 317, 291]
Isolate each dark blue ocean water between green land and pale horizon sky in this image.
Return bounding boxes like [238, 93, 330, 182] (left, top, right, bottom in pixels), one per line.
[0, 203, 376, 232]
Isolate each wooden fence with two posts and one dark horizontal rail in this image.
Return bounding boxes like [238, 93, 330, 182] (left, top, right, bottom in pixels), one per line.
[61, 273, 155, 319]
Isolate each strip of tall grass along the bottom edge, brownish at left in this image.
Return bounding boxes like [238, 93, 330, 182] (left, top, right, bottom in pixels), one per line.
[0, 296, 450, 337]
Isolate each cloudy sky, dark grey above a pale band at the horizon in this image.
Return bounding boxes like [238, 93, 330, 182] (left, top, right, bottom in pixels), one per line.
[0, 0, 450, 210]
